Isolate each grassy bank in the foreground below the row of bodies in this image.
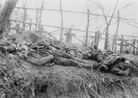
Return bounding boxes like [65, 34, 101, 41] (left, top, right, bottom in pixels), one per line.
[0, 55, 138, 98]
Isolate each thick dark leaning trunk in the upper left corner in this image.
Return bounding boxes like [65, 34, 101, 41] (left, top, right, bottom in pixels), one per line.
[0, 0, 18, 39]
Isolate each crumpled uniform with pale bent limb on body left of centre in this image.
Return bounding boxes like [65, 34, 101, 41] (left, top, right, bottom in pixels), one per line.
[25, 41, 53, 66]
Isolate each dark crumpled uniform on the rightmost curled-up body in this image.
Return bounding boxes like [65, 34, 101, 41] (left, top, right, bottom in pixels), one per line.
[100, 55, 130, 76]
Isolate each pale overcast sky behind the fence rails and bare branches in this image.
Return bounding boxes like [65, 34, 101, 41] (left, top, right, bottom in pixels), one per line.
[1, 0, 138, 48]
